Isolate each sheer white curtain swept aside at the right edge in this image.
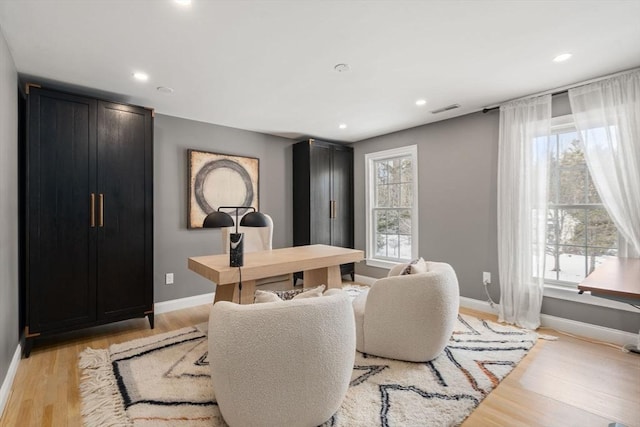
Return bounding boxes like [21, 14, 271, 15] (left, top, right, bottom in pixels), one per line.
[569, 70, 640, 257]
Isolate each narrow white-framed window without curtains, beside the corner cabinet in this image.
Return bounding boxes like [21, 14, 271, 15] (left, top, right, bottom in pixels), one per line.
[365, 145, 418, 268]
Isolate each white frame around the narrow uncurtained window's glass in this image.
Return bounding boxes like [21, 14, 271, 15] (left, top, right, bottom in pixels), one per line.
[365, 145, 420, 269]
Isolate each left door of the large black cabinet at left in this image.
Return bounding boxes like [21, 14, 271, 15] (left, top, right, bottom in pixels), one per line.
[25, 88, 96, 333]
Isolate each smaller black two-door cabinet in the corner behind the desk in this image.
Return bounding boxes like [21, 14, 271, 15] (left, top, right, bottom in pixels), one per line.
[293, 139, 354, 279]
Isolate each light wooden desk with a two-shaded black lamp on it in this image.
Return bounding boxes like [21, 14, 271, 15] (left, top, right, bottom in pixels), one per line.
[189, 245, 364, 304]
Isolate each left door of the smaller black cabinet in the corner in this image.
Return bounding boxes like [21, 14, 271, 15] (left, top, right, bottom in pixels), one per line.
[309, 144, 332, 245]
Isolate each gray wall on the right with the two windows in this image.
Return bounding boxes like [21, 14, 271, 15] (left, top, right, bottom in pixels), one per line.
[353, 104, 638, 333]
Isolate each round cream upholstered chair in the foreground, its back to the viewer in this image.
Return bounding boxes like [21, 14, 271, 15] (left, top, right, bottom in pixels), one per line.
[209, 289, 355, 427]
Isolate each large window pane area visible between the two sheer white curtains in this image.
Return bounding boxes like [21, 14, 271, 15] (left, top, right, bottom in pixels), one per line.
[544, 116, 618, 285]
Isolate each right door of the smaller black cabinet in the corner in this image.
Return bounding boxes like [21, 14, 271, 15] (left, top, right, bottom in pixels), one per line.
[331, 147, 353, 248]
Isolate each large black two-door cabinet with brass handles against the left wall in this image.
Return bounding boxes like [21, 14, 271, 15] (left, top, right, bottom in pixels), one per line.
[22, 86, 153, 356]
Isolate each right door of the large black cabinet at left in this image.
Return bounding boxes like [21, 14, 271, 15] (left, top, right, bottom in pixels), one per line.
[97, 101, 153, 320]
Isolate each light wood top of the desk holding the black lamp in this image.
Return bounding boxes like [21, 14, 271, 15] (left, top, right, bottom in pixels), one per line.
[188, 245, 364, 284]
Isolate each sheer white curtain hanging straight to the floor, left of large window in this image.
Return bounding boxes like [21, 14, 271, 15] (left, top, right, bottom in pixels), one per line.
[498, 95, 551, 329]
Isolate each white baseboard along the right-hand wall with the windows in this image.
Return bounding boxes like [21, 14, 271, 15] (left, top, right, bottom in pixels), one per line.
[355, 275, 638, 346]
